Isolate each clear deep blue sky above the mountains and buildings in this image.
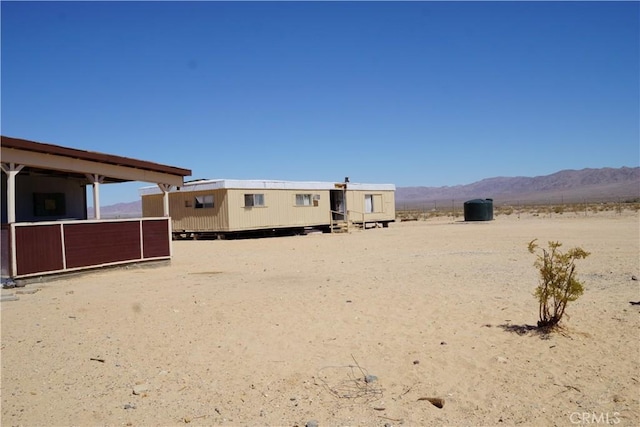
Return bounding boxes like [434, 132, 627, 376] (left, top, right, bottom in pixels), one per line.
[1, 1, 640, 205]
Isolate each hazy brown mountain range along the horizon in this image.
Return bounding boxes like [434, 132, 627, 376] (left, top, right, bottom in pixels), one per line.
[94, 167, 640, 218]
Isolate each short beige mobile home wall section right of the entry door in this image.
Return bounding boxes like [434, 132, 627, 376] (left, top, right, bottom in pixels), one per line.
[347, 189, 396, 222]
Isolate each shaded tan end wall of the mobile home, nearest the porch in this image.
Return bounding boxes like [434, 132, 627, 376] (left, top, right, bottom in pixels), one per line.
[142, 189, 230, 231]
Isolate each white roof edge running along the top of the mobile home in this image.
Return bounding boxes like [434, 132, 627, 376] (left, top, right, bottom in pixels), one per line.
[138, 179, 396, 196]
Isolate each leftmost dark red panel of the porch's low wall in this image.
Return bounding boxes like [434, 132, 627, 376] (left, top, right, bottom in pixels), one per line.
[15, 224, 64, 274]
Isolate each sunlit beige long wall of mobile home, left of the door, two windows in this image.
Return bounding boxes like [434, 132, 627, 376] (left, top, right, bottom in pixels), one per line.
[227, 189, 330, 231]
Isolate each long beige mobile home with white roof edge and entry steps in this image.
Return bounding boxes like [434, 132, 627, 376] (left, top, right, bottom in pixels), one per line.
[139, 179, 395, 238]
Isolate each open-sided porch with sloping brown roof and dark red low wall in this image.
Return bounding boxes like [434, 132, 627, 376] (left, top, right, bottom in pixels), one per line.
[1, 136, 191, 282]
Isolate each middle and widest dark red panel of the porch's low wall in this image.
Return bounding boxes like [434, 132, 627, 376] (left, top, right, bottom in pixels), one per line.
[64, 221, 141, 268]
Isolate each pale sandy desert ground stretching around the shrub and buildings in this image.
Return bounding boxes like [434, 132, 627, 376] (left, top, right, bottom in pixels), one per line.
[1, 212, 640, 427]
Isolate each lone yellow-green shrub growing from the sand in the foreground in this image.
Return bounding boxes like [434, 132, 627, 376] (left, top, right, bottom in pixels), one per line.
[529, 239, 590, 329]
